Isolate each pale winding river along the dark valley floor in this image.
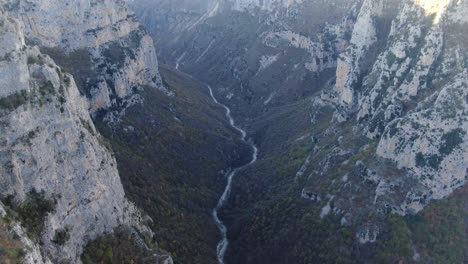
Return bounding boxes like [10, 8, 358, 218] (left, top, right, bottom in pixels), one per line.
[207, 85, 258, 264]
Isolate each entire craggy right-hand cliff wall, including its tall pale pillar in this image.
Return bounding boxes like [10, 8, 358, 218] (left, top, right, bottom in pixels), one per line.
[326, 1, 468, 214]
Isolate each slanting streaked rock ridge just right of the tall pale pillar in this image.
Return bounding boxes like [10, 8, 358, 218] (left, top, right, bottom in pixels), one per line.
[358, 2, 446, 129]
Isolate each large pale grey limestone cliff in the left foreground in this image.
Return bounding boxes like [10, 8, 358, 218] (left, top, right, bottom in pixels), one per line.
[0, 2, 171, 263]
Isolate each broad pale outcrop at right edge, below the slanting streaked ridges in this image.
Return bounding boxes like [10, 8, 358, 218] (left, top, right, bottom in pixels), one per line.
[377, 72, 468, 212]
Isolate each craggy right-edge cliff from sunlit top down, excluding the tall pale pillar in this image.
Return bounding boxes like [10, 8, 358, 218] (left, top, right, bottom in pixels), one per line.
[366, 1, 468, 212]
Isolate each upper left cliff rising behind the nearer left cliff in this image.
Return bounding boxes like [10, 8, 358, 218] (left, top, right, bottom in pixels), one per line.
[6, 0, 170, 121]
